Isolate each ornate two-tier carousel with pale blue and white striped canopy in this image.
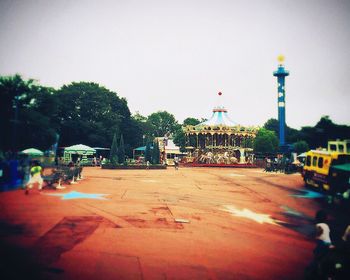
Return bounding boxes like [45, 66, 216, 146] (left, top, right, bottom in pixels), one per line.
[183, 92, 259, 166]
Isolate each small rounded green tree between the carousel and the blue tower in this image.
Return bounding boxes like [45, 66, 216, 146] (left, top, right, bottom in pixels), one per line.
[254, 128, 278, 153]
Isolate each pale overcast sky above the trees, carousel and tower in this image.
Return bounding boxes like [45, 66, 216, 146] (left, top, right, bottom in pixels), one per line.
[0, 0, 350, 129]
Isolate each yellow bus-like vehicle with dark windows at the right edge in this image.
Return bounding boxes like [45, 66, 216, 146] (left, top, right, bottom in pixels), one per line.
[302, 150, 350, 192]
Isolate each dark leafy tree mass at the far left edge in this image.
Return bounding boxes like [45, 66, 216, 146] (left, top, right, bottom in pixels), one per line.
[0, 75, 57, 151]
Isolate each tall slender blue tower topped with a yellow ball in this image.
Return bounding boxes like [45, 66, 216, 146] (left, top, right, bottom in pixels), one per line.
[273, 55, 289, 149]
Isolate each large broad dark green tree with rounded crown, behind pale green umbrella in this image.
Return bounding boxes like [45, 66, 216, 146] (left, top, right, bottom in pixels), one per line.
[57, 82, 133, 147]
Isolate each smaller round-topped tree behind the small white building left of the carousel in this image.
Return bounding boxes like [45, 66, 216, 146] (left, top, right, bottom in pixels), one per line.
[147, 111, 179, 137]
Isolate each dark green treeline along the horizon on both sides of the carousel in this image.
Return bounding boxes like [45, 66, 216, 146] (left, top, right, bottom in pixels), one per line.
[0, 75, 350, 156]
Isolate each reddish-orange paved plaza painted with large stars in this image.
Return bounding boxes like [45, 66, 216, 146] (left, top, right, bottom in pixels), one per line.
[0, 167, 332, 280]
